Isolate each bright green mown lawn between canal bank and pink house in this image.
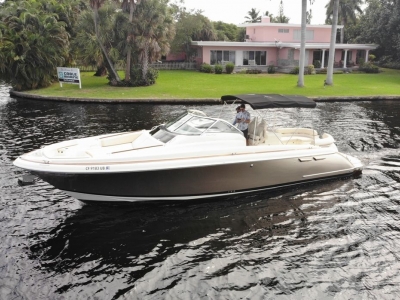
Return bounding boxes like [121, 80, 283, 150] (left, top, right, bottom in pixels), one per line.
[24, 69, 400, 99]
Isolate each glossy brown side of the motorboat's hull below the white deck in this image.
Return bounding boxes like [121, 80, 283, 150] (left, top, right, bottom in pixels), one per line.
[34, 152, 361, 201]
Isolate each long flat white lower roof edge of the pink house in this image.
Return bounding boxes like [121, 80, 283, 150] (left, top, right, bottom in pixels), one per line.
[192, 41, 378, 50]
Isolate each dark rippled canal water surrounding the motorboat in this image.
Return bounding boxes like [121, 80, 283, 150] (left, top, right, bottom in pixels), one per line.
[0, 85, 400, 299]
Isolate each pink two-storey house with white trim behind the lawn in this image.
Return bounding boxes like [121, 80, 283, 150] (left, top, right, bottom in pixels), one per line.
[192, 17, 377, 69]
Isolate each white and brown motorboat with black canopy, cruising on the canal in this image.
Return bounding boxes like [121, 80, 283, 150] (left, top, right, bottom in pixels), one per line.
[14, 94, 362, 201]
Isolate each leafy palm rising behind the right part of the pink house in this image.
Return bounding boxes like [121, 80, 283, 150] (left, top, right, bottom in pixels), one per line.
[325, 0, 364, 44]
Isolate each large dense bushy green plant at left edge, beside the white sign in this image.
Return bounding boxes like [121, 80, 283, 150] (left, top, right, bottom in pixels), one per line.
[0, 1, 69, 90]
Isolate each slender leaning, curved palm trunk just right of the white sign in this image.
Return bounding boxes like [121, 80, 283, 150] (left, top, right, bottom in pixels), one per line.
[89, 0, 121, 85]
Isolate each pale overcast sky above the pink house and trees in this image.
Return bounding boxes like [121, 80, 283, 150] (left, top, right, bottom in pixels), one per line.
[180, 0, 328, 24]
